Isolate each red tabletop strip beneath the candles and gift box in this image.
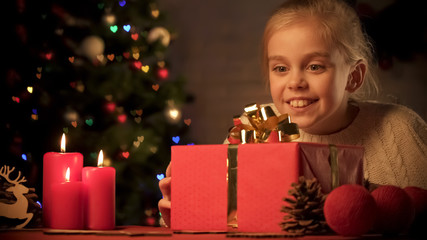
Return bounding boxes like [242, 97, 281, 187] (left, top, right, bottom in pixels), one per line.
[0, 226, 422, 240]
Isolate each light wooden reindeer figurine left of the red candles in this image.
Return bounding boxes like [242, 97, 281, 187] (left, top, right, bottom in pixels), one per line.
[0, 165, 33, 229]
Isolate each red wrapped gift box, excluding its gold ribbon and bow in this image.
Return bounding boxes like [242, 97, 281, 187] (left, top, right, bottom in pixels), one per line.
[171, 142, 363, 232]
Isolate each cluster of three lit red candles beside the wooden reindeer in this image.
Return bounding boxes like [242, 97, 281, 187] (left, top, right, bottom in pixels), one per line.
[43, 136, 116, 230]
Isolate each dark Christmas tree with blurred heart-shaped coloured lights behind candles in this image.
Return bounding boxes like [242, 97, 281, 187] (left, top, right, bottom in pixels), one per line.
[1, 0, 191, 225]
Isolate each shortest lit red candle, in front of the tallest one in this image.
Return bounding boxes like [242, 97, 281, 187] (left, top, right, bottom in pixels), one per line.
[51, 168, 84, 229]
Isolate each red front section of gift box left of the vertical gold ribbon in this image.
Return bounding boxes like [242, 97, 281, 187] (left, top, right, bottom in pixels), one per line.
[171, 144, 228, 231]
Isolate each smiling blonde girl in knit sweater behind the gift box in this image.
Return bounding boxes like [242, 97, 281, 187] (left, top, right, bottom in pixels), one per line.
[159, 0, 427, 225]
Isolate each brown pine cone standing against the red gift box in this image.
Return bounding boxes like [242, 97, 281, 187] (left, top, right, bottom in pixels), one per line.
[281, 176, 329, 234]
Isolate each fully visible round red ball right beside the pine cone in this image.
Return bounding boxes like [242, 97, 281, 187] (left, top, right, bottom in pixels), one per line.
[323, 184, 377, 236]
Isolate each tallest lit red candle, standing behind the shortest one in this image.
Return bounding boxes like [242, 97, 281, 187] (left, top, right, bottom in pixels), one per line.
[42, 135, 83, 227]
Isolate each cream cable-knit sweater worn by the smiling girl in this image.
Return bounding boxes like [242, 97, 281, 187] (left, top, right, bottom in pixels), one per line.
[234, 102, 427, 189]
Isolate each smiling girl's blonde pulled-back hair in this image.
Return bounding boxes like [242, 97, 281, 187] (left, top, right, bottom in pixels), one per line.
[262, 0, 378, 99]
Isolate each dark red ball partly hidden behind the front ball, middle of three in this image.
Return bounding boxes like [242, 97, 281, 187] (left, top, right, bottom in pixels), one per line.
[371, 185, 415, 234]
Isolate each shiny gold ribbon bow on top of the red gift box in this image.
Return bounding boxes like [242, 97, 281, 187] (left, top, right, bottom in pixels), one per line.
[229, 103, 300, 144]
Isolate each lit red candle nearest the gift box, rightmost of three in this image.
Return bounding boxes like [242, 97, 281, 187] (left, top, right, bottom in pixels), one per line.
[82, 150, 116, 230]
